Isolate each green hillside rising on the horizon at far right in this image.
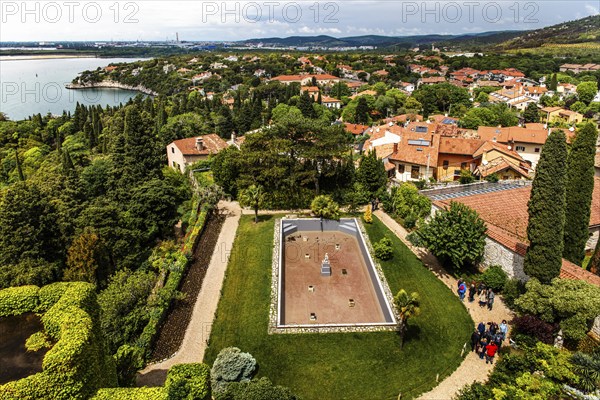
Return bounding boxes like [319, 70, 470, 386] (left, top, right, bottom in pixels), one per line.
[498, 15, 600, 50]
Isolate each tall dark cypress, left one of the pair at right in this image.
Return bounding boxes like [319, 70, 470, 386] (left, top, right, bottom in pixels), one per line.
[523, 130, 567, 284]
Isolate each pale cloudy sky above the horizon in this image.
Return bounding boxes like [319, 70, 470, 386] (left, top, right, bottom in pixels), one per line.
[0, 0, 600, 42]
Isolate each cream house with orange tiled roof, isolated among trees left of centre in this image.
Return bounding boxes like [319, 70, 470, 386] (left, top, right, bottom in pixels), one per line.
[167, 133, 227, 173]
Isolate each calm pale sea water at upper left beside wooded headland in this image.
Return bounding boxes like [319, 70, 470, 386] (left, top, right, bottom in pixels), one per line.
[0, 58, 148, 121]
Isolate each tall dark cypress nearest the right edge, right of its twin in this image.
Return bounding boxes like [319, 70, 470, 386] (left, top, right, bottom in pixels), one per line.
[563, 122, 598, 265]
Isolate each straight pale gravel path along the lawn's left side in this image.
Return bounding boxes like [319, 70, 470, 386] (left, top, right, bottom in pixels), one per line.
[136, 202, 241, 386]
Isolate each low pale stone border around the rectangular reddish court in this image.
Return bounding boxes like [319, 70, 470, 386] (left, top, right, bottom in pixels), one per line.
[268, 215, 400, 335]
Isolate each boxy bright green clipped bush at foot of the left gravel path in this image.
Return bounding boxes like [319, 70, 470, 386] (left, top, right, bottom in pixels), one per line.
[165, 363, 211, 400]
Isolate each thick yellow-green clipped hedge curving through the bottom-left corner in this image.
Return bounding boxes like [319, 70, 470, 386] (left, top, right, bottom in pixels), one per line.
[0, 282, 116, 400]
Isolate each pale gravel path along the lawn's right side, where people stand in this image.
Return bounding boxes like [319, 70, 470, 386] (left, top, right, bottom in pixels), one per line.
[374, 210, 513, 400]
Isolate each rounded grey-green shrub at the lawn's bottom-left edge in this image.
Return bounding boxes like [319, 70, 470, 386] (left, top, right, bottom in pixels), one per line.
[210, 347, 256, 394]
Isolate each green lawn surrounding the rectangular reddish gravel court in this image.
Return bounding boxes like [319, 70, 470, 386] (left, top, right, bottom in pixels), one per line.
[204, 215, 473, 400]
